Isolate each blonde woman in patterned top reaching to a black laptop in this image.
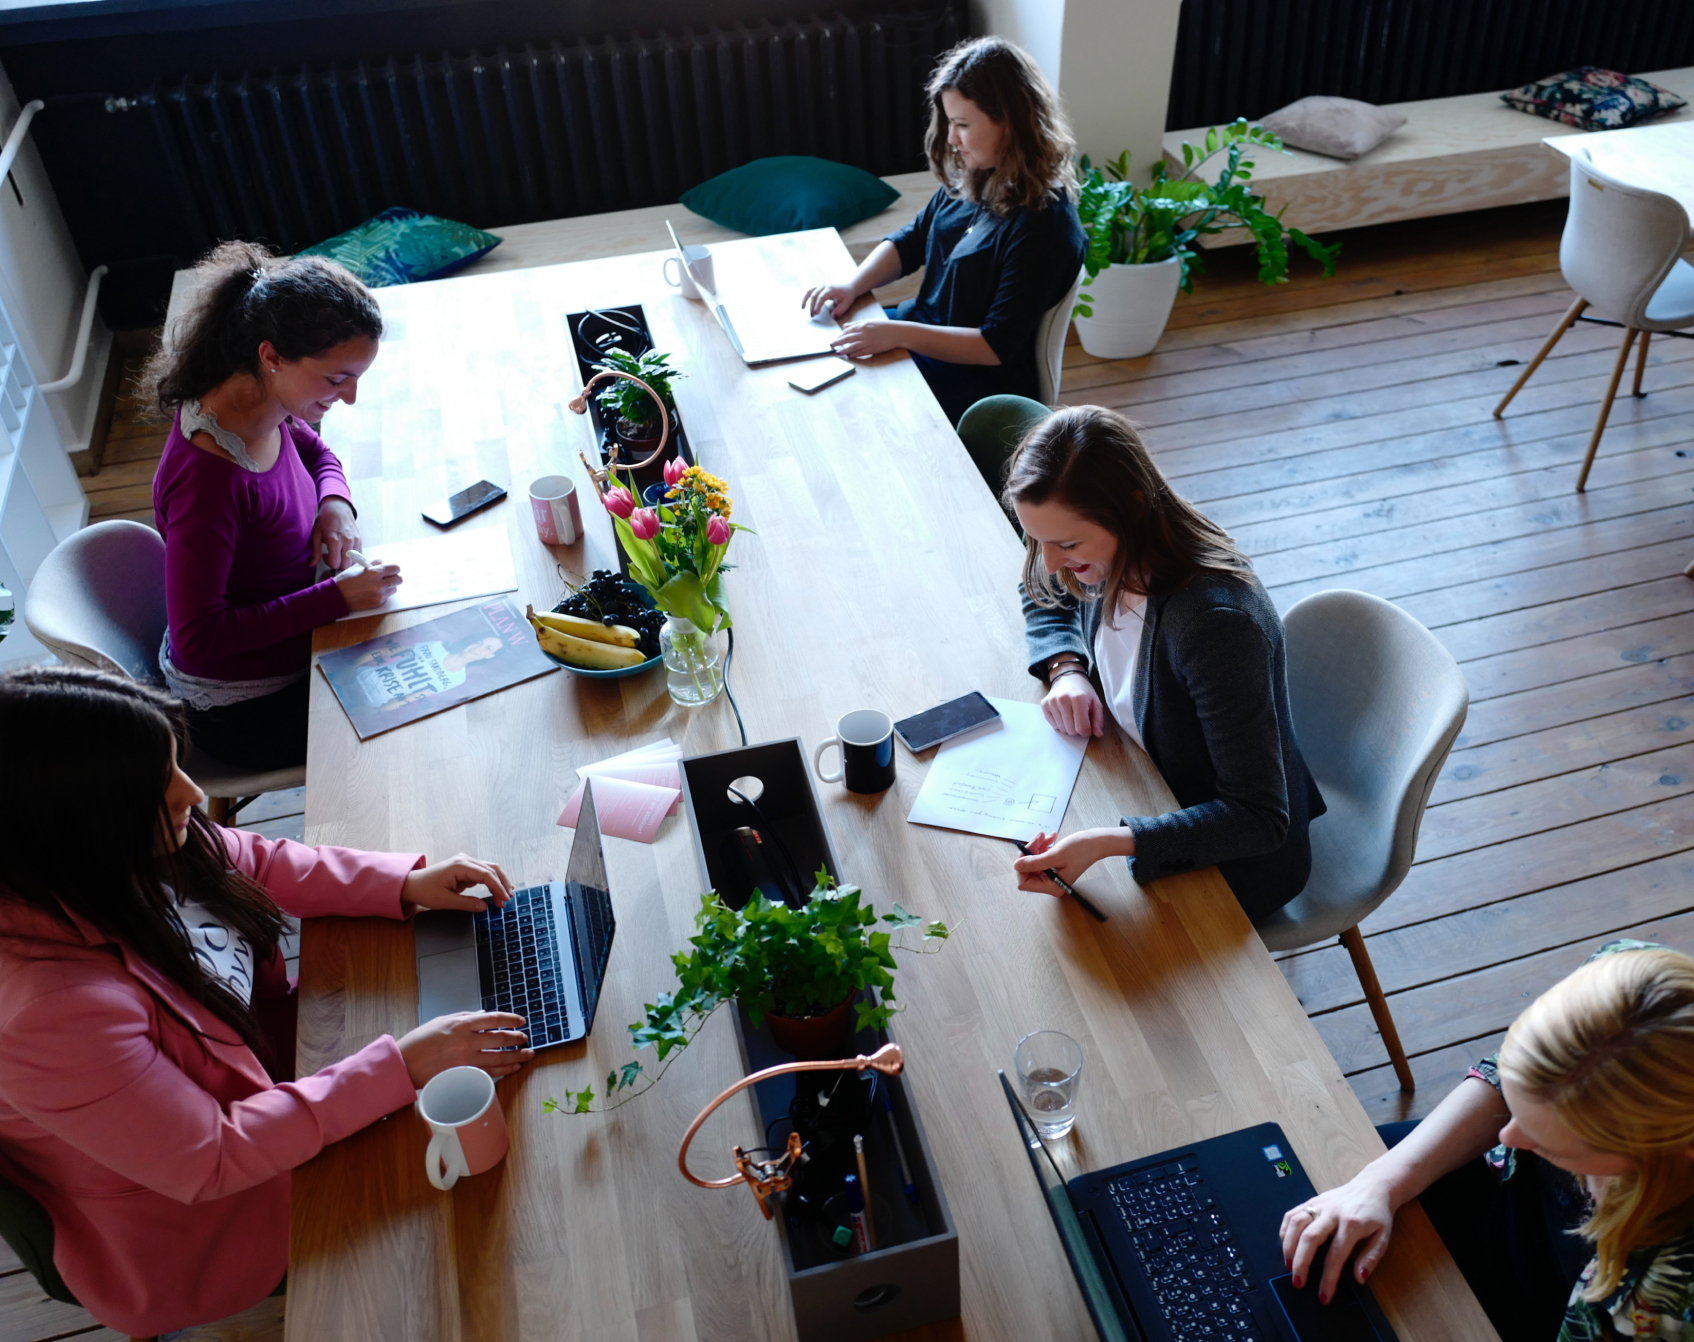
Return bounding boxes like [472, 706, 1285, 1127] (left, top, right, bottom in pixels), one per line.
[1282, 940, 1694, 1342]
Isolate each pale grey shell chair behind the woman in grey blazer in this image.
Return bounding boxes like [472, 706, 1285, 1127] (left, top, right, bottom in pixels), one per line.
[1257, 591, 1470, 1091]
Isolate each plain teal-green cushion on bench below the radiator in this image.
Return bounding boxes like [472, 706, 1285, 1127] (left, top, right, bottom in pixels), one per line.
[683, 154, 900, 237]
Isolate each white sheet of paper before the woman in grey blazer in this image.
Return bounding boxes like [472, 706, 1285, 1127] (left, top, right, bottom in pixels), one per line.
[906, 698, 1088, 839]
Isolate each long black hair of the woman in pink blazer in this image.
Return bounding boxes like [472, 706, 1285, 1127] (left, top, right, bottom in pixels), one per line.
[0, 666, 283, 1056]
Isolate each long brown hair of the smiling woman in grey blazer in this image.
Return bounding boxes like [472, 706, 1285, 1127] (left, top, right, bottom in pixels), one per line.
[1001, 405, 1254, 620]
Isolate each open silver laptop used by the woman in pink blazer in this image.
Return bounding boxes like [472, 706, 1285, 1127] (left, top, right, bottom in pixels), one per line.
[413, 781, 617, 1049]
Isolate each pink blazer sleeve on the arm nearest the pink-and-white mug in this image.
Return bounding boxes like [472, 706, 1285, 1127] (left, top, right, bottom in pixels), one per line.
[0, 983, 415, 1203]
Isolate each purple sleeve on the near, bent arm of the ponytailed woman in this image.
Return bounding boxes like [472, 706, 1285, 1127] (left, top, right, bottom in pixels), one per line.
[158, 468, 347, 669]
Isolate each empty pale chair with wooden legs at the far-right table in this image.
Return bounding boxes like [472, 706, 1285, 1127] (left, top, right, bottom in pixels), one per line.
[1494, 149, 1694, 493]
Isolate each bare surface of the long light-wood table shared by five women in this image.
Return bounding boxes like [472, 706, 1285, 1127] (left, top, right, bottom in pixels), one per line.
[288, 232, 1494, 1342]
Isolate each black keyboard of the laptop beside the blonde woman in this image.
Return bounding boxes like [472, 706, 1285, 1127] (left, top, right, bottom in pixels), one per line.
[1108, 1157, 1260, 1339]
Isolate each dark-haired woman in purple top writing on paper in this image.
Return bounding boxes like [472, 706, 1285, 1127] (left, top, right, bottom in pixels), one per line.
[144, 242, 400, 769]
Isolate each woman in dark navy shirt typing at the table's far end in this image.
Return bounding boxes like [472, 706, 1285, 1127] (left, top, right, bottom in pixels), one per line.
[803, 37, 1086, 424]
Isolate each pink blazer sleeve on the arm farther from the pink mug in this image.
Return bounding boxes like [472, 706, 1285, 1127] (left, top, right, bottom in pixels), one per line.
[220, 830, 424, 918]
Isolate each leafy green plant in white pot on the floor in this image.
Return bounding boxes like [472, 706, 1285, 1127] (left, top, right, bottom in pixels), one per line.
[1076, 117, 1342, 359]
